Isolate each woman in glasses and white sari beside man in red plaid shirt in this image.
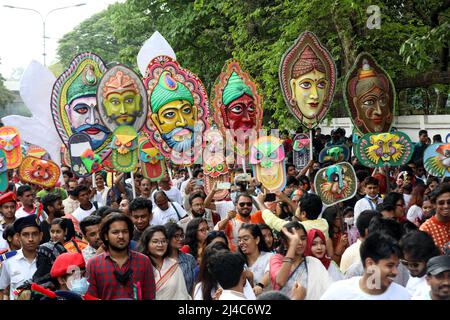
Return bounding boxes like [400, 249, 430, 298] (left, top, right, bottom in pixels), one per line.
[137, 225, 192, 300]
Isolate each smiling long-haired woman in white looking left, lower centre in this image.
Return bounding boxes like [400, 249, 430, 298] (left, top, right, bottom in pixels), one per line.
[238, 223, 273, 294]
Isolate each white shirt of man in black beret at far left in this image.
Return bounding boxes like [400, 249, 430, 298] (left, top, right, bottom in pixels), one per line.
[0, 249, 37, 300]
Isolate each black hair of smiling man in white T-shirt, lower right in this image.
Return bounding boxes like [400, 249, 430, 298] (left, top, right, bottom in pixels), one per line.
[359, 232, 402, 268]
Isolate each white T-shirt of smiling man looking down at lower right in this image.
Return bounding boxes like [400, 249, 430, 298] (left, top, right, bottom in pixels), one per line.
[320, 277, 411, 300]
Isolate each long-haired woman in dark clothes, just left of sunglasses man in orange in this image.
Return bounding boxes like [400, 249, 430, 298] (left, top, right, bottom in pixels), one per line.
[180, 218, 209, 264]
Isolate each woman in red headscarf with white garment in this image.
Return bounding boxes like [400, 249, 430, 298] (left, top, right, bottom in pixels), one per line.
[305, 229, 344, 281]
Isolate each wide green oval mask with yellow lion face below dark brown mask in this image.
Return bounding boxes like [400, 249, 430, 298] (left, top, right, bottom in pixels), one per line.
[355, 131, 414, 168]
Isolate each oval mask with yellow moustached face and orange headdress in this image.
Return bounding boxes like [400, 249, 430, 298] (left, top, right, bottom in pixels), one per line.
[97, 65, 148, 131]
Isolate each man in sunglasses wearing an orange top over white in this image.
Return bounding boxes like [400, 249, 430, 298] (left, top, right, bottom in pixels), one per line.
[214, 193, 264, 252]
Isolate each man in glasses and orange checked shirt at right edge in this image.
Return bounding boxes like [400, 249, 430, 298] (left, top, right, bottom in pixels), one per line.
[420, 183, 450, 253]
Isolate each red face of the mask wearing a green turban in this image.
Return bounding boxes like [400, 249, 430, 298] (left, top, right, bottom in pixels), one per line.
[222, 94, 256, 131]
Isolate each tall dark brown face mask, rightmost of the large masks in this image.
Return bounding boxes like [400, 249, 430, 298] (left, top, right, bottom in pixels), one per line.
[344, 53, 396, 134]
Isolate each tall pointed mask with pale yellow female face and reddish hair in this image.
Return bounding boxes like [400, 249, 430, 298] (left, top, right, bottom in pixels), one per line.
[279, 31, 336, 129]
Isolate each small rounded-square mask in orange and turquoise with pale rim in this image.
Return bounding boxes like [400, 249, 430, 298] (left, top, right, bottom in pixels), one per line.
[314, 162, 357, 206]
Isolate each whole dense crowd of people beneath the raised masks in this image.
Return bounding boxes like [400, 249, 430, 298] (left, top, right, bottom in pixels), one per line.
[0, 129, 450, 300]
